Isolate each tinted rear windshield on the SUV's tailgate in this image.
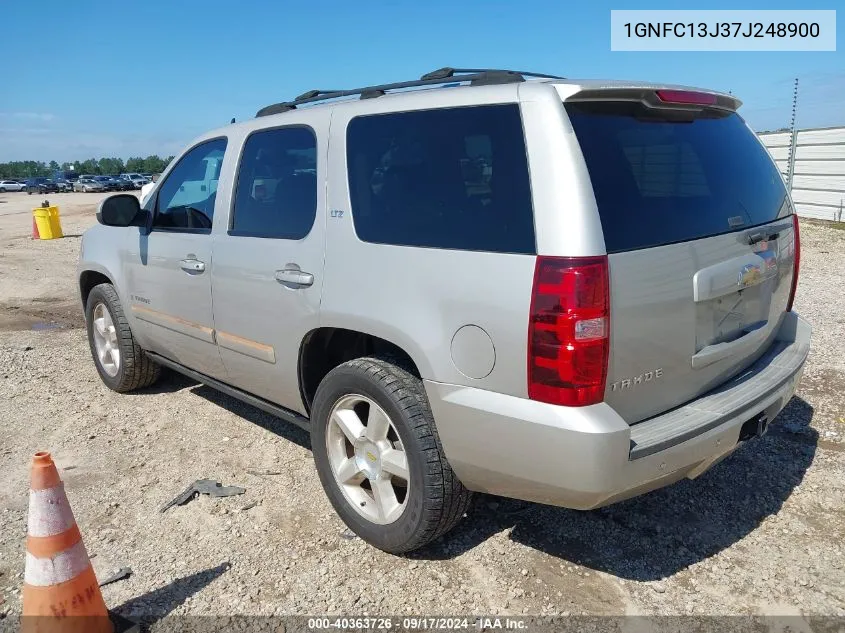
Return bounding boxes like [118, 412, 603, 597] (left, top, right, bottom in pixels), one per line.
[566, 102, 790, 253]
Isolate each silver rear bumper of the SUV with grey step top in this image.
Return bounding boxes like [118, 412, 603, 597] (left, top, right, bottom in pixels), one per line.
[425, 312, 811, 510]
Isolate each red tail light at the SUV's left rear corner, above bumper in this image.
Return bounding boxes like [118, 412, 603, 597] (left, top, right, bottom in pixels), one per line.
[528, 256, 610, 407]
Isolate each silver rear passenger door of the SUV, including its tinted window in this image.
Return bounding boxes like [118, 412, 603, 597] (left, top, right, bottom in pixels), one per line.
[212, 121, 329, 413]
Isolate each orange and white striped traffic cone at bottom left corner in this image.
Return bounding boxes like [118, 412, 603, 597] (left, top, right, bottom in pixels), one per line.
[21, 453, 114, 633]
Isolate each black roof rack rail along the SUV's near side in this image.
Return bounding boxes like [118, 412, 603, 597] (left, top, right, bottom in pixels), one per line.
[255, 66, 563, 117]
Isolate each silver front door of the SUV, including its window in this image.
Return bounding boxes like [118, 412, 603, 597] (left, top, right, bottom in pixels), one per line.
[125, 139, 226, 378]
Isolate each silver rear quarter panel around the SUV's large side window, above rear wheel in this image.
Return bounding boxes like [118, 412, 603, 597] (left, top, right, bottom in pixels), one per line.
[321, 86, 536, 397]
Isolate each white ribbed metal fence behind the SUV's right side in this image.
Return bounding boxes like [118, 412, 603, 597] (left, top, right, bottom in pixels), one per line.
[760, 127, 845, 221]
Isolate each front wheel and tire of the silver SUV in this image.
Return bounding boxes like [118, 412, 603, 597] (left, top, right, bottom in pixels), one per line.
[85, 284, 161, 393]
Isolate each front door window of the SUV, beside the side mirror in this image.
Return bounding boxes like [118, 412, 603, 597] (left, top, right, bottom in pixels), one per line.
[153, 138, 226, 231]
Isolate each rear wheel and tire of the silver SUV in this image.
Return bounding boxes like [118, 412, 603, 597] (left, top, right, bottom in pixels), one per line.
[311, 358, 472, 554]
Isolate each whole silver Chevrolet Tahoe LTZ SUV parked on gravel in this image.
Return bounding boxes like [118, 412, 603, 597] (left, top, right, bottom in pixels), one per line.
[79, 68, 810, 553]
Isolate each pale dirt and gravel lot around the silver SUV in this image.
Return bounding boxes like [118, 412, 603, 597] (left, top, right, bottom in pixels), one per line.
[0, 194, 845, 628]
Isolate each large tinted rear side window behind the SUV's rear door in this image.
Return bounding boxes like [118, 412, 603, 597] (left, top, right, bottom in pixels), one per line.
[347, 105, 535, 253]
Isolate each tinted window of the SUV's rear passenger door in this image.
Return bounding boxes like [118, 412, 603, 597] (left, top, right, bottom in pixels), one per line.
[232, 127, 317, 240]
